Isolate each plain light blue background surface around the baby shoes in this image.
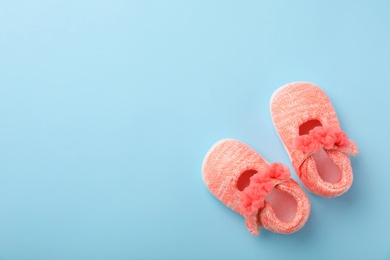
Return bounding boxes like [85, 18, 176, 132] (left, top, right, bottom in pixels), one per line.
[0, 0, 390, 260]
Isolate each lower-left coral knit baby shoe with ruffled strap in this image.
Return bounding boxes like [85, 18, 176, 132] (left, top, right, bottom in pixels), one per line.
[202, 139, 310, 235]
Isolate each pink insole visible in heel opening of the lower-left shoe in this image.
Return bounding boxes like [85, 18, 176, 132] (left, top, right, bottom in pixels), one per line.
[265, 187, 298, 222]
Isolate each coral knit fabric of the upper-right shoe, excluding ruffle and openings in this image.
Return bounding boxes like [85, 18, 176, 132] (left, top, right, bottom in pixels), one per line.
[270, 82, 357, 197]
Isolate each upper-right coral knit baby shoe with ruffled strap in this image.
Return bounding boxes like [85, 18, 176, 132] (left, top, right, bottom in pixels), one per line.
[270, 82, 358, 198]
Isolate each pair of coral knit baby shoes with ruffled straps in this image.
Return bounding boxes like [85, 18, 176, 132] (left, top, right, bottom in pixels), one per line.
[202, 82, 358, 235]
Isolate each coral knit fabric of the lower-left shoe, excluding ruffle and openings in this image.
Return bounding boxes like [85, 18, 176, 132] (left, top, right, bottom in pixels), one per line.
[202, 139, 310, 235]
